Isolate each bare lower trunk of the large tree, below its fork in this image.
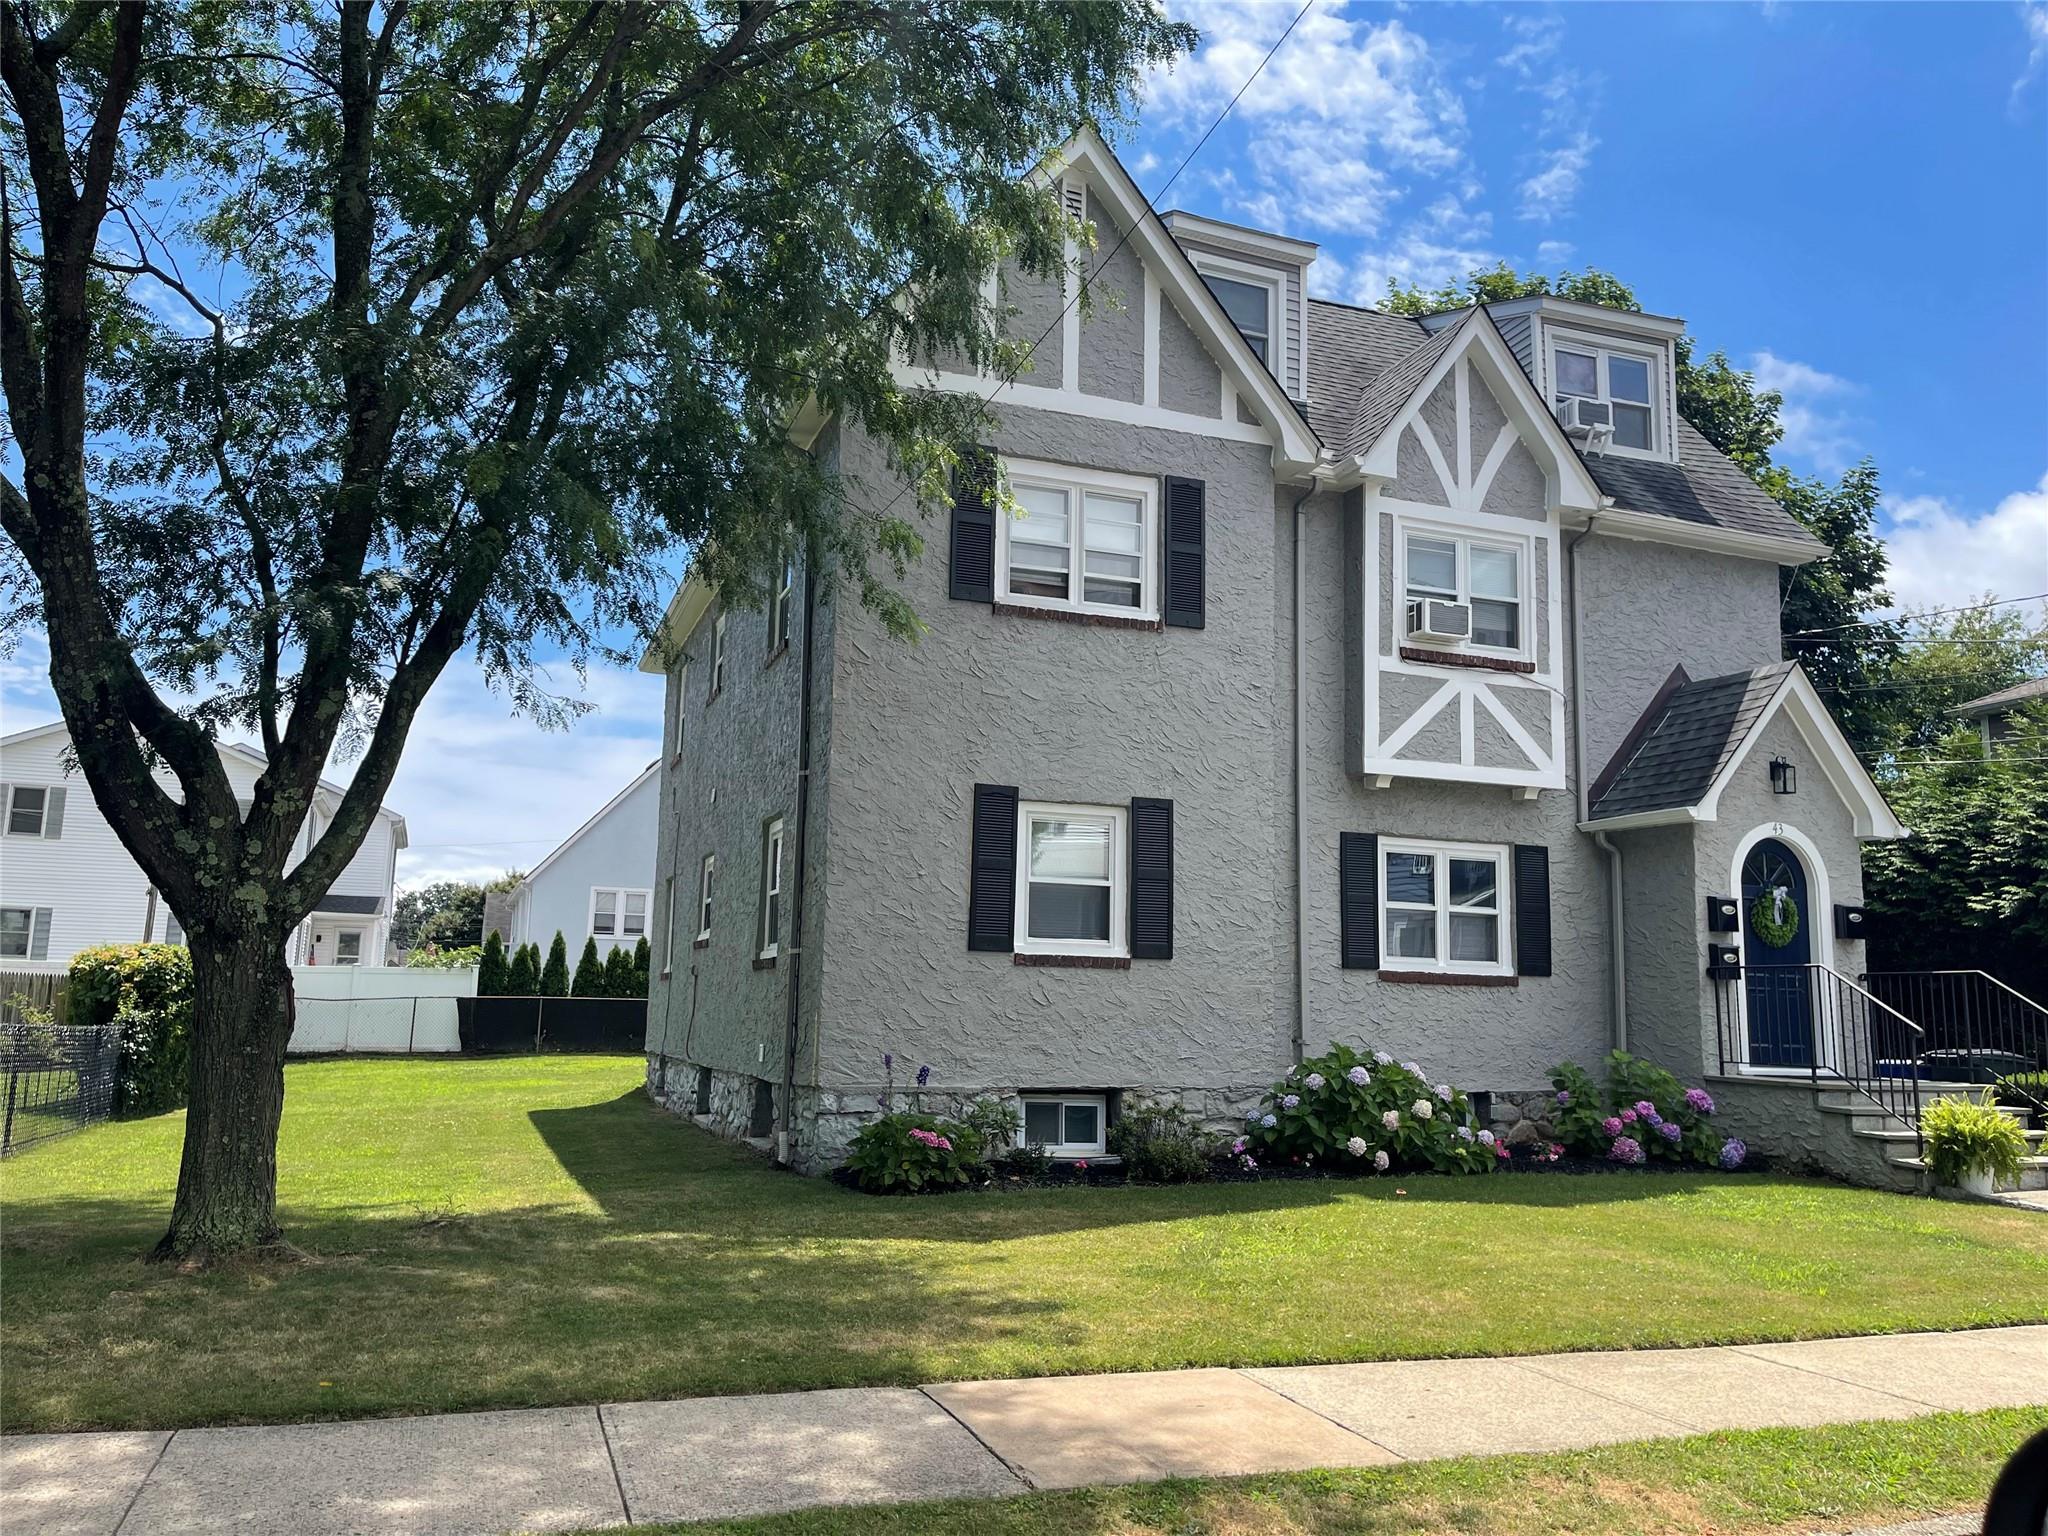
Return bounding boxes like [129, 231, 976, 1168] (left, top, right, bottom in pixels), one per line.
[154, 924, 293, 1264]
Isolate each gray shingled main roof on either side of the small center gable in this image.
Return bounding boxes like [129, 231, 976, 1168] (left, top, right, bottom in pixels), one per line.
[1309, 299, 1821, 551]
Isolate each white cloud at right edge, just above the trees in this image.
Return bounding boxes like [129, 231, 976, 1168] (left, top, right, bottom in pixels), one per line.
[1882, 475, 2048, 608]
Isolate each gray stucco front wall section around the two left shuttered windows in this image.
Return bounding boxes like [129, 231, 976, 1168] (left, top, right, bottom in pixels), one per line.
[819, 408, 1286, 1146]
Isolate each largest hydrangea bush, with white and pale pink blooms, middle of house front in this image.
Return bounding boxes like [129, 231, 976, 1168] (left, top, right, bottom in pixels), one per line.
[1233, 1044, 1507, 1174]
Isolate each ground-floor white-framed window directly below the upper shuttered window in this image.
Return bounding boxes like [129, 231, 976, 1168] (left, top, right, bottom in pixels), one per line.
[1016, 805, 1130, 956]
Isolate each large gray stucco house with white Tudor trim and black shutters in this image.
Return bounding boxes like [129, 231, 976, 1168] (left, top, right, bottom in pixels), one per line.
[645, 133, 1905, 1169]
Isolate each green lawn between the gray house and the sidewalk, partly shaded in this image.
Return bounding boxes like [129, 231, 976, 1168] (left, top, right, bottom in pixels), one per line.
[0, 1057, 2048, 1430]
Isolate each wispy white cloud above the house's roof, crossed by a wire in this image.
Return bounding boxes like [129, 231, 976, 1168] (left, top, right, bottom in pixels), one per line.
[1147, 0, 1464, 236]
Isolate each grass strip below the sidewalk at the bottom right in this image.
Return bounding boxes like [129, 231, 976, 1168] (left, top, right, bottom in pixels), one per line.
[635, 1409, 2048, 1536]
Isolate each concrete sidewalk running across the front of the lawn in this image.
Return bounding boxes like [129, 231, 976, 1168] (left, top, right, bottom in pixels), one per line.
[0, 1327, 2048, 1536]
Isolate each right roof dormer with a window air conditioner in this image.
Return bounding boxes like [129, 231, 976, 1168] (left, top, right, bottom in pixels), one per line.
[1421, 295, 1686, 465]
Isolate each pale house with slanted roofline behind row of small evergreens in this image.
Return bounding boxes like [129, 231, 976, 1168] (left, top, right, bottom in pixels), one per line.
[502, 762, 662, 965]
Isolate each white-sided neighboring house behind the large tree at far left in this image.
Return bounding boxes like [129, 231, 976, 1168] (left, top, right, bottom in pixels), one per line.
[0, 721, 407, 965]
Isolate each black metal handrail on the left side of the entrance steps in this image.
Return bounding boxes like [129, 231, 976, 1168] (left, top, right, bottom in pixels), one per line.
[1714, 963, 1927, 1147]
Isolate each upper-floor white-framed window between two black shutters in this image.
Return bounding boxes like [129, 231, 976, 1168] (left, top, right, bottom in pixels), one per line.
[995, 461, 1159, 618]
